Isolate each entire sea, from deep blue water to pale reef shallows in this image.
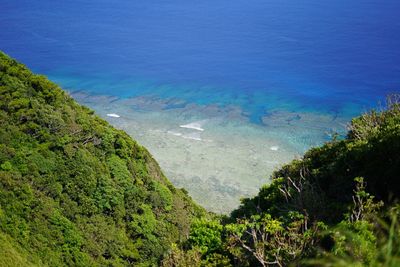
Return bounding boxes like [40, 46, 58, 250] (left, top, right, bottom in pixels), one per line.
[0, 0, 400, 213]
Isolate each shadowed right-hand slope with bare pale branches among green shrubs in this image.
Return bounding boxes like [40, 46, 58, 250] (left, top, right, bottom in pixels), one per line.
[163, 95, 400, 266]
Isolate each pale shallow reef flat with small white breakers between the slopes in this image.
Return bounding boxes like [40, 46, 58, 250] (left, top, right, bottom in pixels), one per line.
[72, 92, 346, 213]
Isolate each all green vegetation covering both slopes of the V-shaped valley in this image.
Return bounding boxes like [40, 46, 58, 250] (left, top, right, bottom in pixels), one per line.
[0, 53, 400, 267]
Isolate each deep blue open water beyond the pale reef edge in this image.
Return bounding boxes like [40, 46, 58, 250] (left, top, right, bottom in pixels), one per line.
[0, 0, 400, 122]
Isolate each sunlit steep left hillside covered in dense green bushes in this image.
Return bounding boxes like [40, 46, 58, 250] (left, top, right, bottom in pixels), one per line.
[0, 52, 204, 266]
